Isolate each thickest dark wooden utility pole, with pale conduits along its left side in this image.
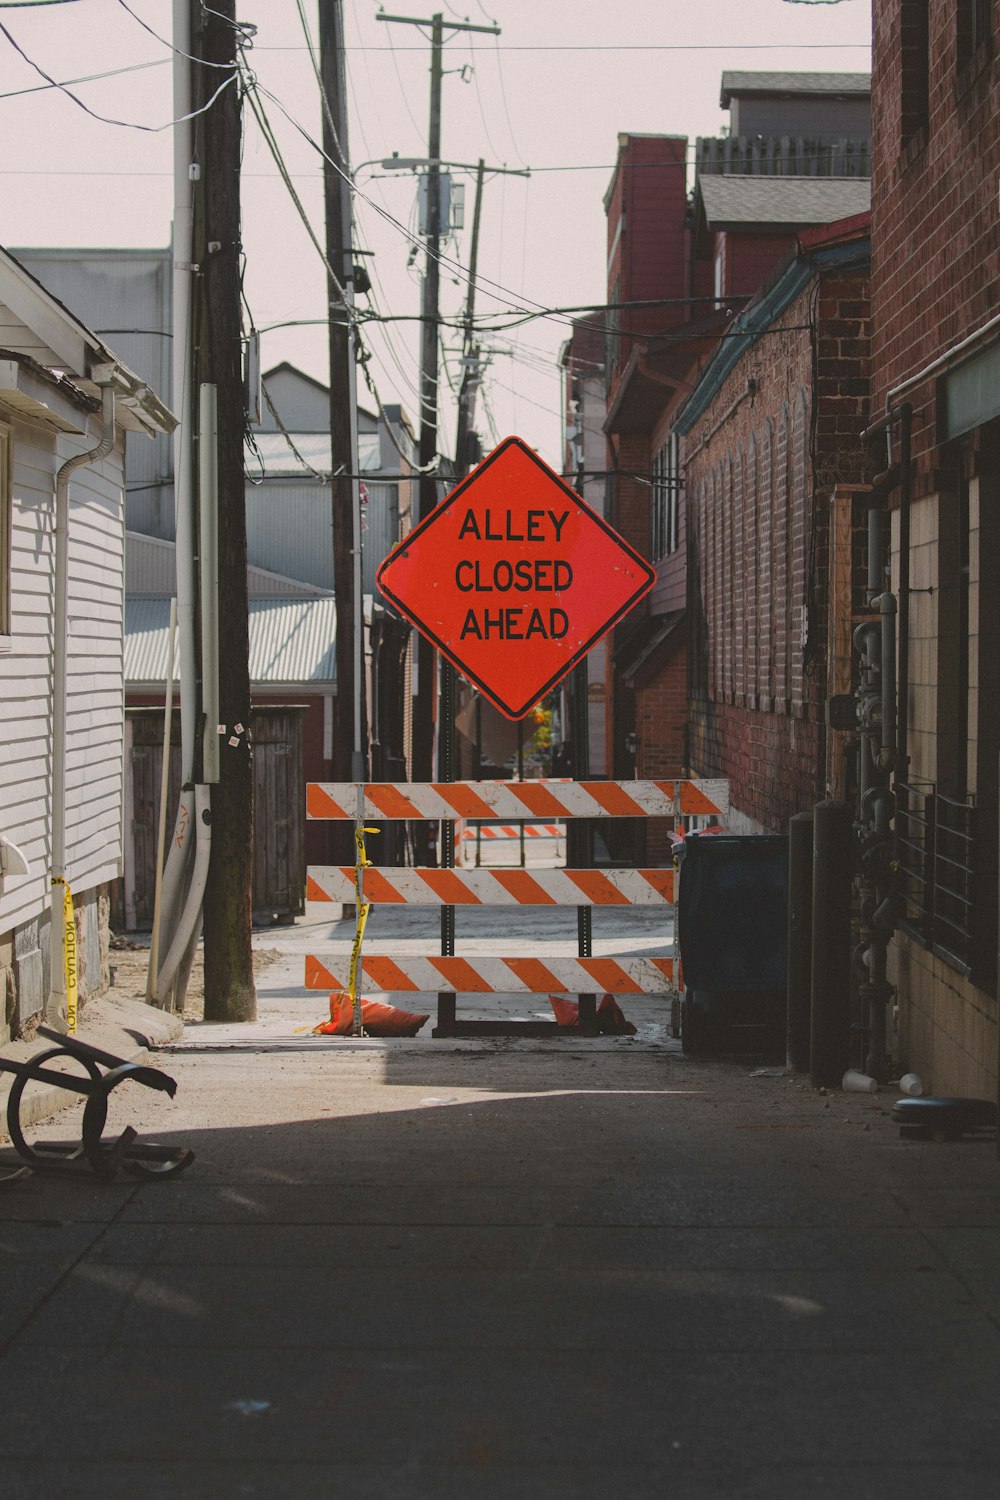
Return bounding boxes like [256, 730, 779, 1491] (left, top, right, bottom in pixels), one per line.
[195, 0, 256, 1022]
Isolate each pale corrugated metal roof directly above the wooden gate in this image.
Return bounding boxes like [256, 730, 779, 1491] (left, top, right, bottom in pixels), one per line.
[124, 596, 337, 689]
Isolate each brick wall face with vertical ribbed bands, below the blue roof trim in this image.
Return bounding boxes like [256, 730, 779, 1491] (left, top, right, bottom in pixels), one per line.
[687, 250, 868, 831]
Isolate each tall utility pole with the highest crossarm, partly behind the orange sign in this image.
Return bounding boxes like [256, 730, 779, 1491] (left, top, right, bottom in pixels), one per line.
[376, 11, 501, 782]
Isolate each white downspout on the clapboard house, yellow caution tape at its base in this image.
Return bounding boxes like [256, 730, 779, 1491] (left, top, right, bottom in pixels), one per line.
[45, 375, 115, 1031]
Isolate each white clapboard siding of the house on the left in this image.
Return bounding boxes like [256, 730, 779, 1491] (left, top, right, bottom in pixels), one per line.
[0, 420, 124, 932]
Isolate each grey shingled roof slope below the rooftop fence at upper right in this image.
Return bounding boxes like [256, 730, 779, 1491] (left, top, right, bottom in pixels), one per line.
[699, 176, 871, 230]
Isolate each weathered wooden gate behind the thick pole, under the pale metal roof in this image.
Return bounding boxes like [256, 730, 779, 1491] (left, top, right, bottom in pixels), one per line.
[124, 707, 306, 932]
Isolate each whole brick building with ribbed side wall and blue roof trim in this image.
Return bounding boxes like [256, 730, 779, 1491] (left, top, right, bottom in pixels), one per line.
[673, 215, 870, 833]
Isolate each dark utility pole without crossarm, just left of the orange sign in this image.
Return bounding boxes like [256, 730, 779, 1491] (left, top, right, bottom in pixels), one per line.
[319, 0, 367, 863]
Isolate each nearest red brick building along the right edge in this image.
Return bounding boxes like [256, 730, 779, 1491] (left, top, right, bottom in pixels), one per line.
[871, 0, 1000, 1095]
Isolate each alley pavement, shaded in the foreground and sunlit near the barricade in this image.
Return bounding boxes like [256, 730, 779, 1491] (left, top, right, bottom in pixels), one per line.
[0, 911, 1000, 1500]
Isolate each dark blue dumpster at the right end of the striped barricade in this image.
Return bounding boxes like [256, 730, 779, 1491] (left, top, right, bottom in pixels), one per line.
[678, 834, 789, 1062]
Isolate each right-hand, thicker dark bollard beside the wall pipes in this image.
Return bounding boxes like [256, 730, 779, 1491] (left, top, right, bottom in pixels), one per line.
[810, 798, 853, 1089]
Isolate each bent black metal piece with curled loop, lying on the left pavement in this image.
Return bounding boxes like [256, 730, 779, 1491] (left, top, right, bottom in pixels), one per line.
[0, 1026, 195, 1182]
